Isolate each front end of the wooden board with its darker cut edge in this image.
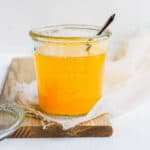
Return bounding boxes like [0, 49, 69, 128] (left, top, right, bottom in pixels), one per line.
[11, 114, 112, 138]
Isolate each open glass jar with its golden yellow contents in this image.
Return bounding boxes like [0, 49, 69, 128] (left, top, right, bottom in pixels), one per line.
[30, 25, 110, 116]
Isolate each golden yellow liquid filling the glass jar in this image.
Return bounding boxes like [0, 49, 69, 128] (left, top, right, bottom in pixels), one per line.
[35, 52, 106, 115]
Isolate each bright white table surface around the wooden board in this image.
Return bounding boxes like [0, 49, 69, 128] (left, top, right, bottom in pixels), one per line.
[0, 48, 150, 150]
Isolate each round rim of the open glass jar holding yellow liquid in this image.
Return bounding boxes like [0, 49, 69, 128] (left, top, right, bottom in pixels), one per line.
[29, 24, 111, 43]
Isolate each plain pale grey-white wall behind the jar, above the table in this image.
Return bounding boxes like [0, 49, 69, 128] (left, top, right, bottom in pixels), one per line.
[0, 0, 150, 51]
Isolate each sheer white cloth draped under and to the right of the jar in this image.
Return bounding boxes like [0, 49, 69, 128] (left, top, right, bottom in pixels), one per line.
[16, 33, 150, 129]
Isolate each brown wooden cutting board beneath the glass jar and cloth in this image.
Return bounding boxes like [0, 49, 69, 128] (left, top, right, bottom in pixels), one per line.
[1, 58, 113, 138]
